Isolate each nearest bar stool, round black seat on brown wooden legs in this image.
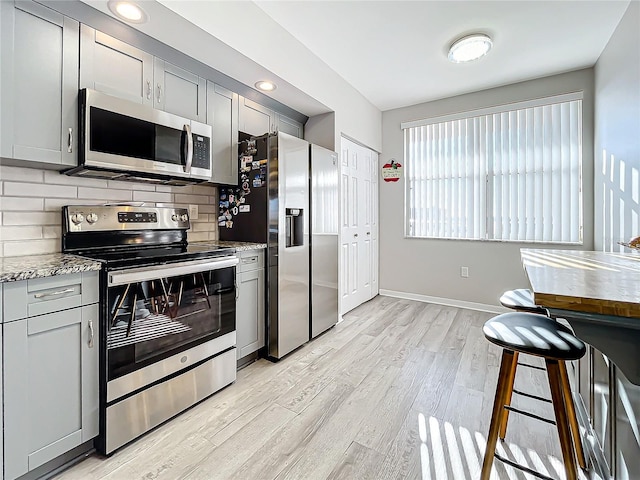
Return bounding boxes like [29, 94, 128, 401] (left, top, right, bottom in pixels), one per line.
[480, 312, 586, 480]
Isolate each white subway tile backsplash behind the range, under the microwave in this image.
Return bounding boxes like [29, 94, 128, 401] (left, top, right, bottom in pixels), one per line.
[0, 165, 218, 257]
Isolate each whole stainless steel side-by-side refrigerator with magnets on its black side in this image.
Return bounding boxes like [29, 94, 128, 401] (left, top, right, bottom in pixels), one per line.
[218, 133, 339, 359]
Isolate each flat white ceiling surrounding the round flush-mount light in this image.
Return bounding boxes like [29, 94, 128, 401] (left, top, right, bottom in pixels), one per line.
[251, 0, 629, 111]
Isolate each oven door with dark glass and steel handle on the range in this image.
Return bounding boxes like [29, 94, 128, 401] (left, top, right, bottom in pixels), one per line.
[105, 256, 238, 384]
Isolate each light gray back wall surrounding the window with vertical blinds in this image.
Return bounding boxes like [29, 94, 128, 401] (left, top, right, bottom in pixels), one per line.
[380, 69, 593, 305]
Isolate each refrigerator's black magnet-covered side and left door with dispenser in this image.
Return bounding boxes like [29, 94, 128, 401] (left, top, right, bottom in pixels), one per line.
[218, 129, 310, 359]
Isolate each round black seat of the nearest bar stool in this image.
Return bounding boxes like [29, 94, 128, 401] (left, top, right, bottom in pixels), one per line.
[482, 312, 586, 360]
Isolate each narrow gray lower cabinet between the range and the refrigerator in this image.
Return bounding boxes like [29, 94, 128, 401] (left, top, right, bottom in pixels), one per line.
[236, 250, 265, 359]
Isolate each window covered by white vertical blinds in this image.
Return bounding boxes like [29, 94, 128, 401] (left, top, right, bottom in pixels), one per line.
[402, 93, 582, 243]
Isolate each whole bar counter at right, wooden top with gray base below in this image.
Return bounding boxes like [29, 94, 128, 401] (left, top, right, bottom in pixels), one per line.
[520, 248, 640, 480]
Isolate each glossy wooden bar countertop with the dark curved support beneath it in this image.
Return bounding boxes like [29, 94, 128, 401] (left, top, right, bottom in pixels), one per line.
[520, 248, 640, 385]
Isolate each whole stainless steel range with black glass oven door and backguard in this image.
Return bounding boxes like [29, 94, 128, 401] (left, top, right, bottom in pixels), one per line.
[62, 205, 238, 455]
